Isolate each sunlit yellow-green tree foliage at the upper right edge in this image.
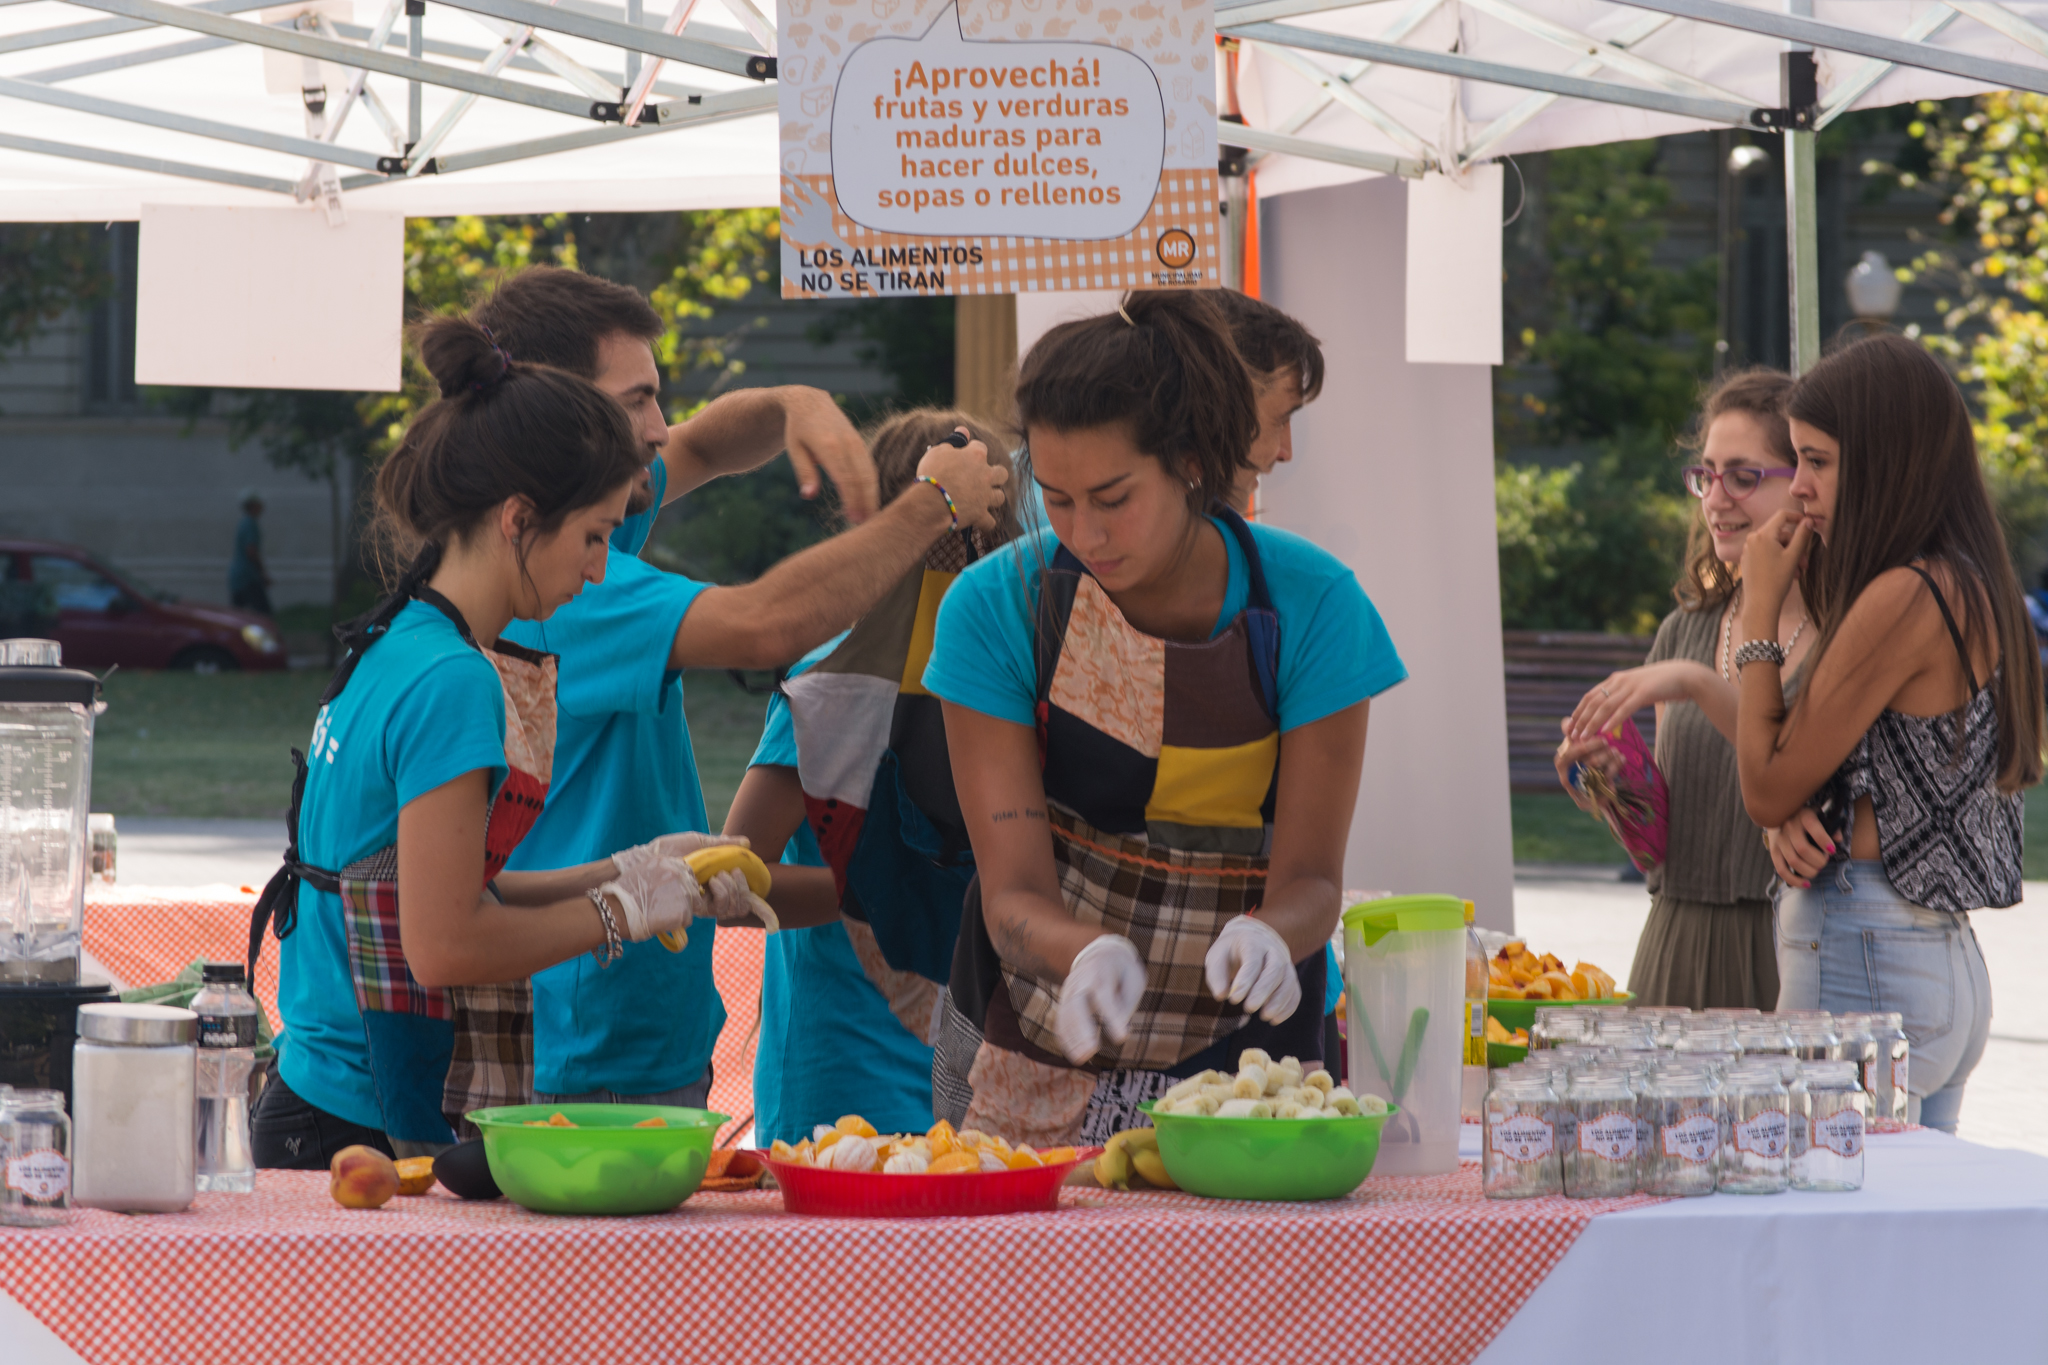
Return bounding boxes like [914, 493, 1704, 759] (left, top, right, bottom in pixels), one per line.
[1866, 90, 2048, 577]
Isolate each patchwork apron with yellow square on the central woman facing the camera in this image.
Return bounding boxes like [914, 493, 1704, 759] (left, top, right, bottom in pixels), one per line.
[932, 508, 1323, 1146]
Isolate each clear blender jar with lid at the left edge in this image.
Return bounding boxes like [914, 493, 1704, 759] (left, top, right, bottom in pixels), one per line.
[0, 641, 98, 984]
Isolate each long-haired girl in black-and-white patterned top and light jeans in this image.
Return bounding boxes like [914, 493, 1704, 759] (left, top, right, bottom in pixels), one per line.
[1735, 336, 2042, 1132]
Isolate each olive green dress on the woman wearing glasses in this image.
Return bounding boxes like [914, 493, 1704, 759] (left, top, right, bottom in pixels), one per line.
[1628, 608, 1778, 1009]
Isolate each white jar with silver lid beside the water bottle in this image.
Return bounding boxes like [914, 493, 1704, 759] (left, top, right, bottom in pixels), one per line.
[72, 1005, 199, 1214]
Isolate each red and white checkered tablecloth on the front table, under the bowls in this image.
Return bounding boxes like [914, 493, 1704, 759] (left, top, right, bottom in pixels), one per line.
[0, 1164, 1653, 1365]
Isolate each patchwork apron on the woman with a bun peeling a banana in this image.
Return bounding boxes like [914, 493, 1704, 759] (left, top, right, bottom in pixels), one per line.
[248, 583, 555, 1154]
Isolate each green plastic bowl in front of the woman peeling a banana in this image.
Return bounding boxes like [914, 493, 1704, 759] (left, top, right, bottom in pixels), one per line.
[469, 1105, 725, 1214]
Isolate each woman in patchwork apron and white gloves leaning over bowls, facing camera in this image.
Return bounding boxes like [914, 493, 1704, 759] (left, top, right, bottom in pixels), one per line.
[924, 293, 1407, 1146]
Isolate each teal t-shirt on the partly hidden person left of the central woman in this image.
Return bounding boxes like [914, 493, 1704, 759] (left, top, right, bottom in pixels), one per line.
[748, 634, 932, 1146]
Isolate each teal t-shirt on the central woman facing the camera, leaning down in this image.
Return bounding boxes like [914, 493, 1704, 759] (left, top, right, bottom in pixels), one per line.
[924, 522, 1407, 733]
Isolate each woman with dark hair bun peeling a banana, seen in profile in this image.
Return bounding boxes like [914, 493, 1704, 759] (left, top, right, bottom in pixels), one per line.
[250, 317, 743, 1169]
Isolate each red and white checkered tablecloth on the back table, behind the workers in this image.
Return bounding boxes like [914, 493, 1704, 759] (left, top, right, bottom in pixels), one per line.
[86, 886, 762, 1138]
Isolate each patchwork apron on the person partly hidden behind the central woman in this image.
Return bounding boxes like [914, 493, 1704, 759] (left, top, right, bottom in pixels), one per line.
[782, 532, 995, 1044]
